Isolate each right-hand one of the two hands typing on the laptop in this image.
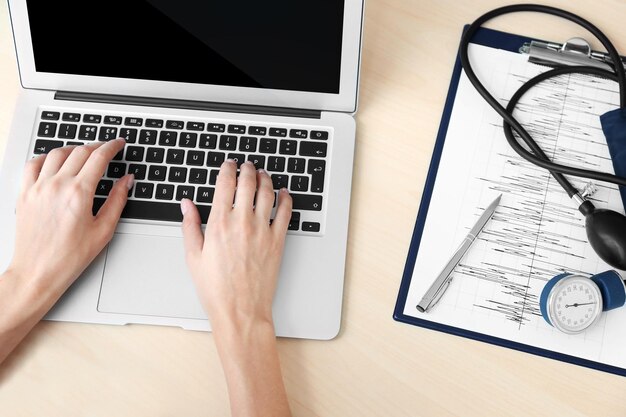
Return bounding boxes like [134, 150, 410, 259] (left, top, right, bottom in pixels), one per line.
[181, 161, 292, 330]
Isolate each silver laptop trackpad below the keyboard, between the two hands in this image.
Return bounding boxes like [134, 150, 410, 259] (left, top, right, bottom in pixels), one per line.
[98, 233, 206, 319]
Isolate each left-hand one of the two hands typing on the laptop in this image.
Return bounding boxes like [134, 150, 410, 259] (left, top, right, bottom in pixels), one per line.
[8, 139, 134, 298]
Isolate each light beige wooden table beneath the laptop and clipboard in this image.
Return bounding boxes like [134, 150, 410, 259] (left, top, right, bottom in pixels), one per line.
[0, 0, 626, 417]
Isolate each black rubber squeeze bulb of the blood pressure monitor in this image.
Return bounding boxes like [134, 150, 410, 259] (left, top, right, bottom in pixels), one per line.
[579, 201, 626, 270]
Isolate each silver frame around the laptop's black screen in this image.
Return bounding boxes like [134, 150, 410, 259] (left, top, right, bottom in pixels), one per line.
[8, 0, 364, 112]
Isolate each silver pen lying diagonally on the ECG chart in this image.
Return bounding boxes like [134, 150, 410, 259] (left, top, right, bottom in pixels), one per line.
[416, 194, 502, 313]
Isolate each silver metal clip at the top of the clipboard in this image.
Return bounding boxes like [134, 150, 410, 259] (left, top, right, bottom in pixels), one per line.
[519, 38, 626, 71]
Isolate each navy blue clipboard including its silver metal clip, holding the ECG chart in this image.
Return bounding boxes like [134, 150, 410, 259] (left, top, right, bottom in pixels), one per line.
[393, 26, 626, 376]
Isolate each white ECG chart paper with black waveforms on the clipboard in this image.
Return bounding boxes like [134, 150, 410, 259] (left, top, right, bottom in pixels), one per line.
[404, 44, 626, 368]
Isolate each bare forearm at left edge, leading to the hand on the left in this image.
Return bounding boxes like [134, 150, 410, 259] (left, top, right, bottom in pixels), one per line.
[0, 271, 58, 363]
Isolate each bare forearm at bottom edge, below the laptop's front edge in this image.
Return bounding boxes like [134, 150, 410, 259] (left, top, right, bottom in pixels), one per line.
[213, 323, 291, 417]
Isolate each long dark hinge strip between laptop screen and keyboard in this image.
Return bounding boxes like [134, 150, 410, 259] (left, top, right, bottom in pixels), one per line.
[54, 91, 322, 119]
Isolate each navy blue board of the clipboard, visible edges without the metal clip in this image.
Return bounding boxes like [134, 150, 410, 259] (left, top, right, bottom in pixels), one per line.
[393, 28, 626, 376]
